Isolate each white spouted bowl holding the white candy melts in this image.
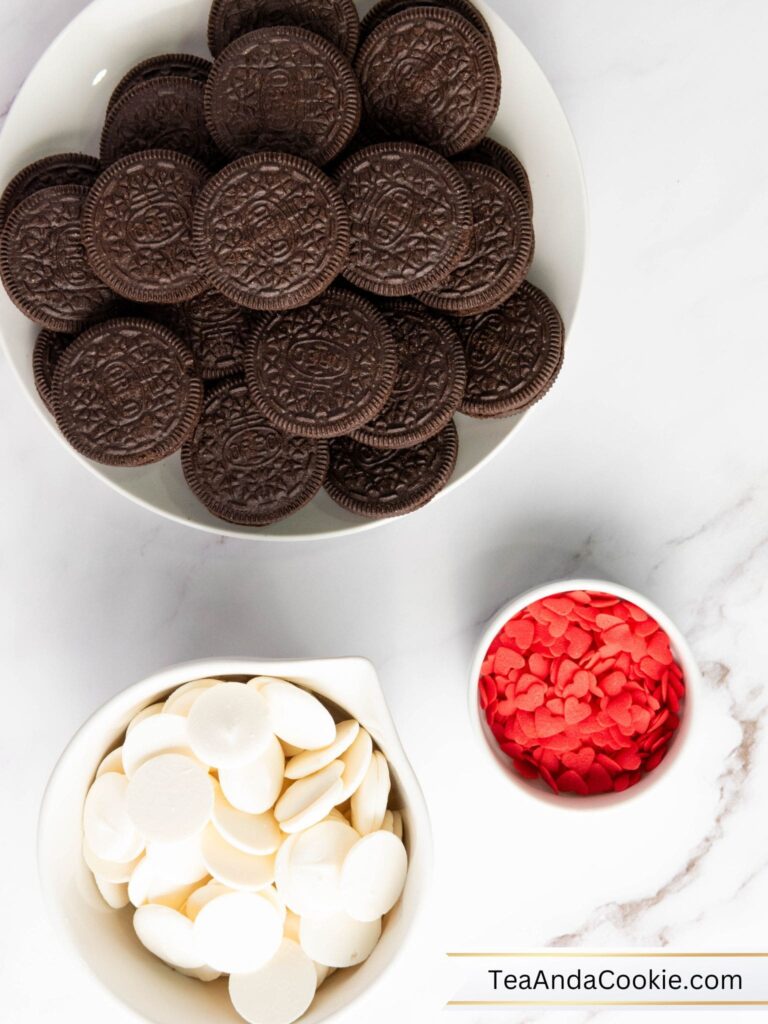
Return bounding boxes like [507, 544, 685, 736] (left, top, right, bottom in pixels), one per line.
[38, 657, 432, 1024]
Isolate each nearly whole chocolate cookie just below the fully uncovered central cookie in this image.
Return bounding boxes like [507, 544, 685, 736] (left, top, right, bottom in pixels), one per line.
[246, 288, 397, 437]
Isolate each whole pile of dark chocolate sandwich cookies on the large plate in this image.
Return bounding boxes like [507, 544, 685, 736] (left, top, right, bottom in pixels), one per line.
[0, 0, 563, 526]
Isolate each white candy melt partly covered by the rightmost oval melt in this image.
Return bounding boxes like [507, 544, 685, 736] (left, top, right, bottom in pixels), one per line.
[275, 820, 359, 916]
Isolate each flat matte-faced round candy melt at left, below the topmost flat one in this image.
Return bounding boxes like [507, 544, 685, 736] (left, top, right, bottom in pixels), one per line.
[127, 757, 213, 843]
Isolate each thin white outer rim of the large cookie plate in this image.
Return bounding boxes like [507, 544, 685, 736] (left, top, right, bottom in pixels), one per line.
[0, 0, 591, 543]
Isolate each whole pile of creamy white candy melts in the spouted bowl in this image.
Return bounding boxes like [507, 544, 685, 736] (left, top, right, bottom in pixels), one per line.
[83, 677, 408, 1024]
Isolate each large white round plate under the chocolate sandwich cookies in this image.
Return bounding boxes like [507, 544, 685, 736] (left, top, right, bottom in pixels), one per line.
[0, 0, 587, 540]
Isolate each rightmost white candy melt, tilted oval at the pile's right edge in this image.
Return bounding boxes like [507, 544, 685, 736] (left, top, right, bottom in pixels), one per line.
[339, 831, 408, 921]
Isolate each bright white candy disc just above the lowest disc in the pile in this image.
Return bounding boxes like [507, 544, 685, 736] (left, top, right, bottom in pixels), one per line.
[193, 893, 283, 974]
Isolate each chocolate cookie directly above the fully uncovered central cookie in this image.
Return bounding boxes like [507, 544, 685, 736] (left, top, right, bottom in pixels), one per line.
[206, 26, 361, 165]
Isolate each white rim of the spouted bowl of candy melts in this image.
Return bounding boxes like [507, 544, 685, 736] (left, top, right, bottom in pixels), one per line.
[37, 655, 433, 1024]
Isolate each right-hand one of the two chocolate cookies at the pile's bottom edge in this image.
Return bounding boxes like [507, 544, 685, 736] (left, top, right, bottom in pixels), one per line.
[326, 423, 459, 519]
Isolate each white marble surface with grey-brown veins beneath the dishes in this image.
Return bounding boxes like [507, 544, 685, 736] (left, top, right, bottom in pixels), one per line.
[0, 0, 768, 1024]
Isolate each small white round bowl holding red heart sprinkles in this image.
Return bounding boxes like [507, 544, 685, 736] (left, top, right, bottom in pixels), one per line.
[469, 580, 700, 811]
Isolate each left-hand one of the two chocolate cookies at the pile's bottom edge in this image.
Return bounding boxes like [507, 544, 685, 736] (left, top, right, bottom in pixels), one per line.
[181, 378, 329, 526]
